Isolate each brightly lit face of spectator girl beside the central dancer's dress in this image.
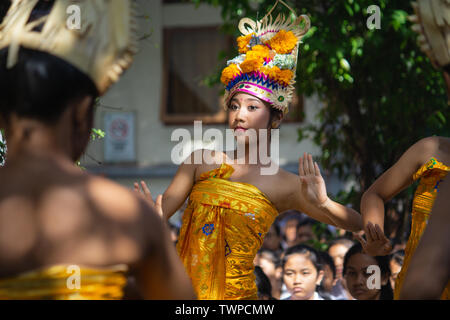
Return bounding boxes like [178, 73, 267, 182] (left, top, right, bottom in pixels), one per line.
[283, 253, 323, 300]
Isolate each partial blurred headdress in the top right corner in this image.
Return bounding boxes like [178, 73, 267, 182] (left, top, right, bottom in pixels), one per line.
[410, 0, 450, 68]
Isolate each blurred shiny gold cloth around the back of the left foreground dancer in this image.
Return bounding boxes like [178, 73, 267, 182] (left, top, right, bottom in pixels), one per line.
[0, 265, 127, 300]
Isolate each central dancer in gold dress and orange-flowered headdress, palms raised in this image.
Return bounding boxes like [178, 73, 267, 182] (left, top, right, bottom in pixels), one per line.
[135, 1, 362, 299]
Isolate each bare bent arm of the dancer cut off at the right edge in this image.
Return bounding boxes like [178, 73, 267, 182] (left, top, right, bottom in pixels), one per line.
[359, 137, 439, 256]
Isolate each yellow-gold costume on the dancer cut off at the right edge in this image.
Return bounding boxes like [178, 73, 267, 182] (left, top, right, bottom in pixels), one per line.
[394, 158, 450, 300]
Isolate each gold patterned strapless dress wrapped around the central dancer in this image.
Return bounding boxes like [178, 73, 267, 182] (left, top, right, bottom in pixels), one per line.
[177, 164, 278, 300]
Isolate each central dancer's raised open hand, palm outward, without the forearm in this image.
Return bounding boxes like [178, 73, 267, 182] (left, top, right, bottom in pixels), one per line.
[298, 152, 329, 207]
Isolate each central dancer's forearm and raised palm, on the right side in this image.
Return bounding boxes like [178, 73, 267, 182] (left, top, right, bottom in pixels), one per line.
[286, 153, 362, 232]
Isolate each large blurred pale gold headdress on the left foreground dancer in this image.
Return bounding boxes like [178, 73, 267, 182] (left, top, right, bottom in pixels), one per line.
[0, 0, 137, 95]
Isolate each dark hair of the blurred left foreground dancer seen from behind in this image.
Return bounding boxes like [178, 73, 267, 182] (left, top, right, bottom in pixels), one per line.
[0, 48, 98, 124]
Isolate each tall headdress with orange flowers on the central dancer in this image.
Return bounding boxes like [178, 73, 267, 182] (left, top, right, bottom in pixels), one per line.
[221, 0, 311, 114]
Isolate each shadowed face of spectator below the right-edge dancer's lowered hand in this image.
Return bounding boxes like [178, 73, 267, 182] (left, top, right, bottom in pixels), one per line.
[344, 253, 387, 300]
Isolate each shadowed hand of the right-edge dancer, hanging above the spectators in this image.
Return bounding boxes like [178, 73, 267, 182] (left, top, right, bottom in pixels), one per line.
[356, 222, 392, 257]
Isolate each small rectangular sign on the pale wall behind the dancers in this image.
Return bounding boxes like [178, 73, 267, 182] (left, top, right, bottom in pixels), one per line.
[104, 112, 136, 162]
